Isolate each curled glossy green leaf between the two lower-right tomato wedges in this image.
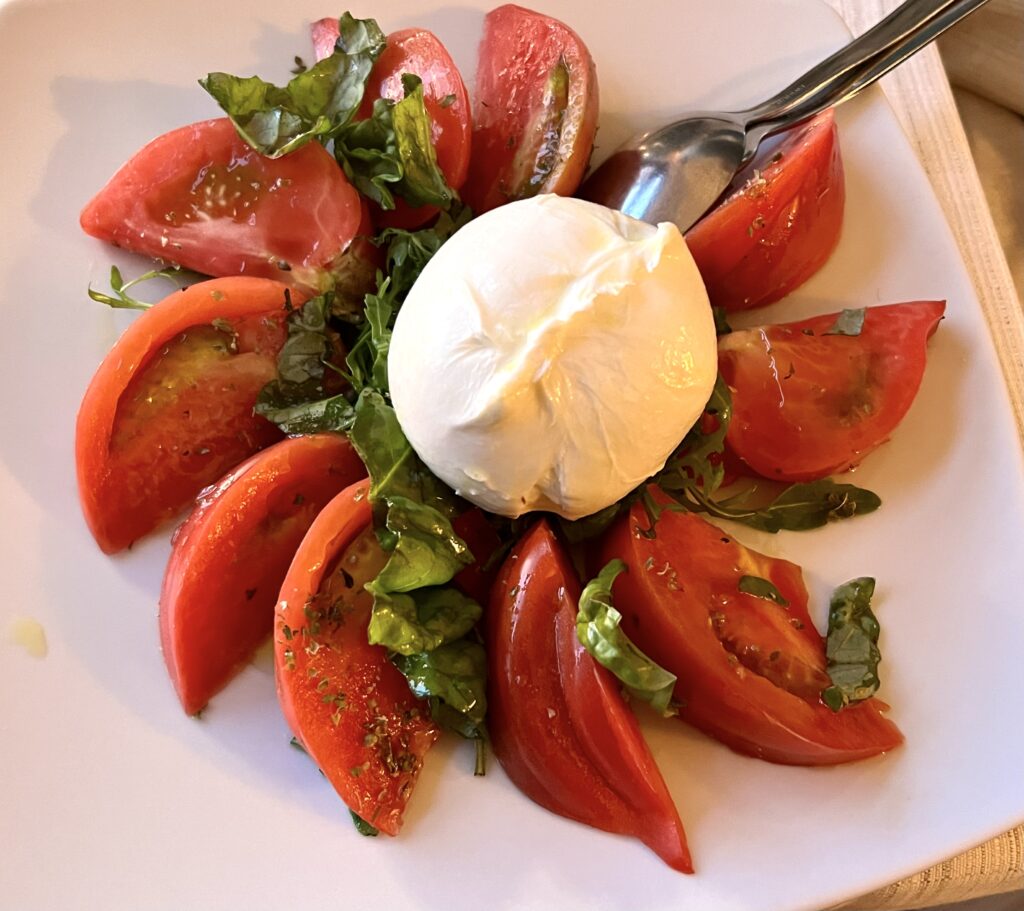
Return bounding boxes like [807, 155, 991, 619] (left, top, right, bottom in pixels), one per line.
[577, 560, 676, 715]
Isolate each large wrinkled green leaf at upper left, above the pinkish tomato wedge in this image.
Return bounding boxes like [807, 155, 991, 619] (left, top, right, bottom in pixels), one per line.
[200, 12, 386, 158]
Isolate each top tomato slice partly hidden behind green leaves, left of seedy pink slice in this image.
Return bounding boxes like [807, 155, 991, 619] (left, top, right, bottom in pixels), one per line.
[310, 18, 472, 229]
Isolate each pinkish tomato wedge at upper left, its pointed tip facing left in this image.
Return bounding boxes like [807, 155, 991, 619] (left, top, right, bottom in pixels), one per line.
[81, 118, 369, 290]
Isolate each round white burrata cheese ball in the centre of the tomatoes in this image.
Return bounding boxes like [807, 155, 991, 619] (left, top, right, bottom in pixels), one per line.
[388, 196, 718, 519]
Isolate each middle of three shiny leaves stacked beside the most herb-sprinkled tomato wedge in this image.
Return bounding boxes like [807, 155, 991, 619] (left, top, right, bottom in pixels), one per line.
[367, 579, 482, 656]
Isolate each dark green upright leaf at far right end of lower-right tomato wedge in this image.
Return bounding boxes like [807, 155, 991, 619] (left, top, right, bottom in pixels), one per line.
[821, 576, 882, 711]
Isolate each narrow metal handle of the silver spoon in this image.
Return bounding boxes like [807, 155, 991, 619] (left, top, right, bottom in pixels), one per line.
[738, 0, 987, 142]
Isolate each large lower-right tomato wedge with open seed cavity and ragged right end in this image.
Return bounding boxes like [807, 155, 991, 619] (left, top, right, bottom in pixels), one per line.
[601, 488, 903, 766]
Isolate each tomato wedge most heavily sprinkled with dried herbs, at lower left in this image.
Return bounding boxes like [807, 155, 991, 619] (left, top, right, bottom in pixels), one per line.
[273, 483, 438, 835]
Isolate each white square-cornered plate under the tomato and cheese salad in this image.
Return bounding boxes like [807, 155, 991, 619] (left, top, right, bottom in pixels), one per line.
[0, 0, 1024, 911]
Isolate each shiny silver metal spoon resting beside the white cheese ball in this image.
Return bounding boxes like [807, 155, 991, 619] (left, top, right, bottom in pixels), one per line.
[579, 0, 987, 231]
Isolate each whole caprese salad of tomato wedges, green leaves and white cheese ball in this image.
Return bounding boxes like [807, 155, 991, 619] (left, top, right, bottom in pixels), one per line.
[76, 5, 944, 872]
